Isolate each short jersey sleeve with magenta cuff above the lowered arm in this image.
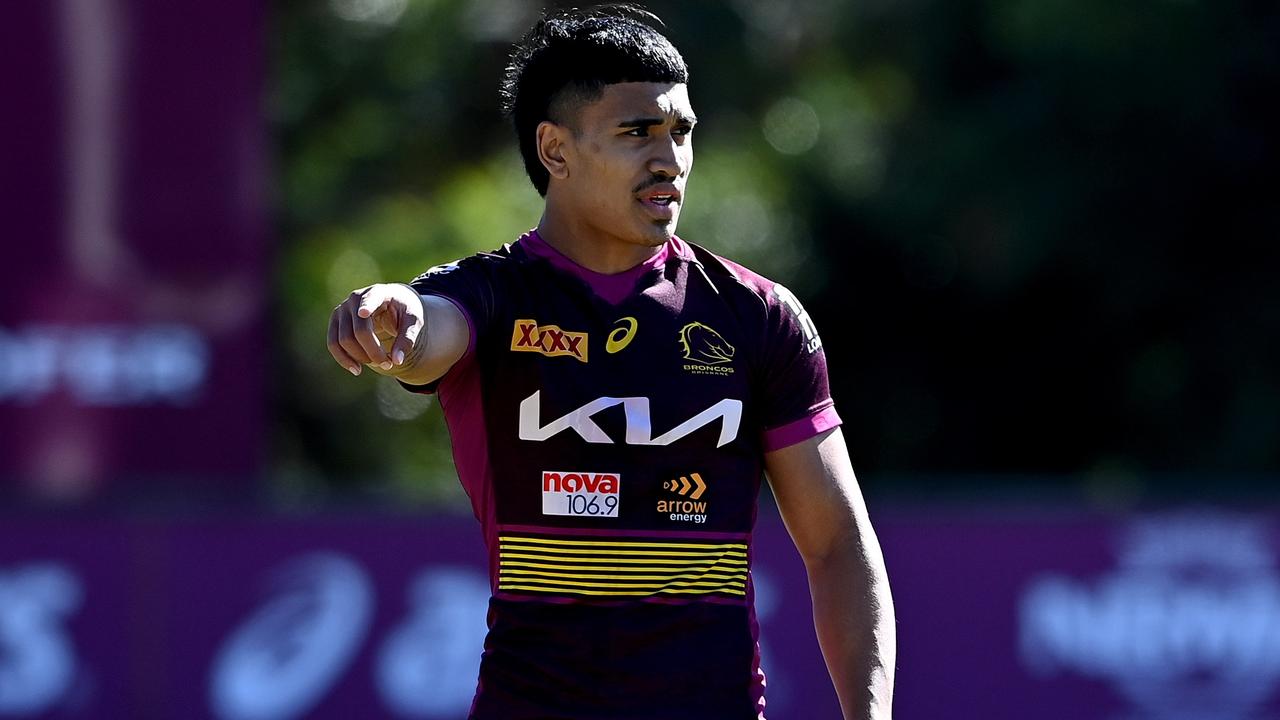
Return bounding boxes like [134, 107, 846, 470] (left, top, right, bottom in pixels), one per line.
[762, 284, 840, 452]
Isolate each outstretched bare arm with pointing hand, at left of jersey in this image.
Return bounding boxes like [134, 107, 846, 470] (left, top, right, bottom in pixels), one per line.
[328, 283, 471, 384]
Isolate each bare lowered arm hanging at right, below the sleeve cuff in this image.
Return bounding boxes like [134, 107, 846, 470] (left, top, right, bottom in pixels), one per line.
[764, 428, 897, 720]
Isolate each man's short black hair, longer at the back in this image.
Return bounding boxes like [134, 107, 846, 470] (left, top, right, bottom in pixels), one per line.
[502, 4, 689, 196]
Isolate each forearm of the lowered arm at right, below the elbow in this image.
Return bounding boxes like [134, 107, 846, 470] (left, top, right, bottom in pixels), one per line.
[806, 523, 897, 720]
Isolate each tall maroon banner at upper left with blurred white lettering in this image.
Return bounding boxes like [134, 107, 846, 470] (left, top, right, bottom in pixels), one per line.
[0, 0, 266, 498]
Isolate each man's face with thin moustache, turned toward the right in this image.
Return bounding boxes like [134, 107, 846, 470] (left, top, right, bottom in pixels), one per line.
[561, 82, 698, 246]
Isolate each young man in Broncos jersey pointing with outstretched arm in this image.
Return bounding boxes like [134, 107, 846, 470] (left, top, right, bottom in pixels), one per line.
[329, 6, 895, 720]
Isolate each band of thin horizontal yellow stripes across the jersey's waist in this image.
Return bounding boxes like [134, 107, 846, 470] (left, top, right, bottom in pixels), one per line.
[498, 536, 748, 598]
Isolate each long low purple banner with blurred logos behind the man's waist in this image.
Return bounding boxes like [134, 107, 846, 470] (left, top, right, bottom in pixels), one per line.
[0, 510, 1280, 720]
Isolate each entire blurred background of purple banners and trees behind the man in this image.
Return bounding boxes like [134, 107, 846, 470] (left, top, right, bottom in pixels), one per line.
[0, 0, 1280, 720]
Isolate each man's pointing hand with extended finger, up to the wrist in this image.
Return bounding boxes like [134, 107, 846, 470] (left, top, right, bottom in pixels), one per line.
[329, 283, 426, 375]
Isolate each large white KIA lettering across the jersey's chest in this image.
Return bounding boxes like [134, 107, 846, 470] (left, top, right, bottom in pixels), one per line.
[520, 391, 742, 447]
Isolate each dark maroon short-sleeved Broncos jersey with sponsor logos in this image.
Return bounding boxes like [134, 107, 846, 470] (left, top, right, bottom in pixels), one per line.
[412, 232, 840, 720]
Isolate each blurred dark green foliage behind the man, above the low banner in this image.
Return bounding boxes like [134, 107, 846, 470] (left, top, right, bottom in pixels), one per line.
[270, 0, 1280, 506]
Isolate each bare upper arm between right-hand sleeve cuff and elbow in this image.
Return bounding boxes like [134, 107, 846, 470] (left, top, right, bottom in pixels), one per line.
[764, 428, 867, 562]
